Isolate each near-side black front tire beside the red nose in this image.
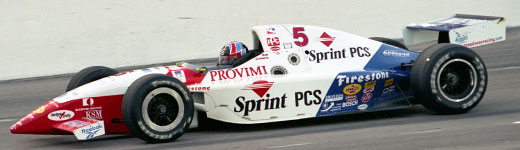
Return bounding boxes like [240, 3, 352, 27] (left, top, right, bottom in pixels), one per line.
[122, 74, 194, 143]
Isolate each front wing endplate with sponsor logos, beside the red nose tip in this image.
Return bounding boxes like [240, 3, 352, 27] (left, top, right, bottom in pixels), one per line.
[52, 118, 105, 140]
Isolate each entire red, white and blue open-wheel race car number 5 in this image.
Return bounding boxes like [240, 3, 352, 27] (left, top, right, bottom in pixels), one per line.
[10, 15, 505, 143]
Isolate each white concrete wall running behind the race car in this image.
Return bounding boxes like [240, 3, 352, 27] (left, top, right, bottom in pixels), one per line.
[0, 0, 520, 80]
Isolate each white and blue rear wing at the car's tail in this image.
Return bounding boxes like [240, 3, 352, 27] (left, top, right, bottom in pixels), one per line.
[403, 14, 506, 47]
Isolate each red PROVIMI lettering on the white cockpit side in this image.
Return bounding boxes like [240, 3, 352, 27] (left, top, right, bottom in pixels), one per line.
[209, 66, 268, 81]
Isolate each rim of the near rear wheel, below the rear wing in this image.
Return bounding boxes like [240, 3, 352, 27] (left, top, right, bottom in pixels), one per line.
[436, 59, 477, 102]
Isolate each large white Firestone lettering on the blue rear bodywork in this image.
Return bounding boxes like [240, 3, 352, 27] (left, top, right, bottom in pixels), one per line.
[336, 71, 390, 86]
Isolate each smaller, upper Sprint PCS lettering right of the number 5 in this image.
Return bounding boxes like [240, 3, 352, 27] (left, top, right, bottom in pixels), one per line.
[305, 47, 372, 63]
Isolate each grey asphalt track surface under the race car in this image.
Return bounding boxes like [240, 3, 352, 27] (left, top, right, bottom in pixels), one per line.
[0, 28, 520, 150]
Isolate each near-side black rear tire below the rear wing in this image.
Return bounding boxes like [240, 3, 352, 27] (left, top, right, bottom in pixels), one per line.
[411, 43, 488, 114]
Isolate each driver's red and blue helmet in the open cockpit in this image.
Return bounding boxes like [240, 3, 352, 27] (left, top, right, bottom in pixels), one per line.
[218, 41, 248, 65]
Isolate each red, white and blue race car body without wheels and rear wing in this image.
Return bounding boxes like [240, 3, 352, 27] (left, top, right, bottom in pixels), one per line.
[11, 25, 419, 139]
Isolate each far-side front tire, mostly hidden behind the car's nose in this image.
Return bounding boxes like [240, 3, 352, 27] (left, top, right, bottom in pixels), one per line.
[65, 66, 119, 92]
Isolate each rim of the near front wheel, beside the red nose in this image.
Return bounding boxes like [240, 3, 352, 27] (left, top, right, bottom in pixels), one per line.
[142, 87, 184, 132]
